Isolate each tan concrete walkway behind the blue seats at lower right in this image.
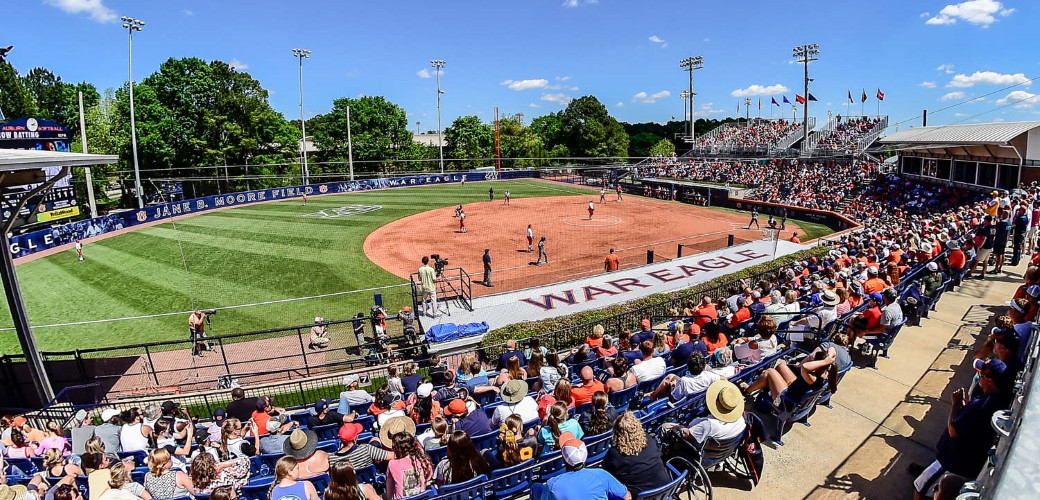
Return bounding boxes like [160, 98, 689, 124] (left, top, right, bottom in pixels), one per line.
[709, 264, 1025, 500]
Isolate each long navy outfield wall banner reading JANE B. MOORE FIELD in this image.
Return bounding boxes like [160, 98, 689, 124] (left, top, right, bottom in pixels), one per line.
[8, 170, 535, 258]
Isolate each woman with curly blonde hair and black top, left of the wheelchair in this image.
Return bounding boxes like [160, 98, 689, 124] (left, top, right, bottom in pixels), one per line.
[602, 412, 672, 498]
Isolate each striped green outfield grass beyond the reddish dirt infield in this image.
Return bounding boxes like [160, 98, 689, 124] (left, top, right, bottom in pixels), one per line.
[0, 181, 603, 352]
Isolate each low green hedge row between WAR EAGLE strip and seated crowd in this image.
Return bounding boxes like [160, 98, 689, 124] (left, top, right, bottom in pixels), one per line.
[480, 246, 828, 358]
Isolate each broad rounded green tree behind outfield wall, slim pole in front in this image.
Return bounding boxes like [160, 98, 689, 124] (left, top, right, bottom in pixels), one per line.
[312, 96, 414, 172]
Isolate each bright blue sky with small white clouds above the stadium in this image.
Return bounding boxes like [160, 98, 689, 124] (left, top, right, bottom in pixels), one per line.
[6, 0, 1040, 130]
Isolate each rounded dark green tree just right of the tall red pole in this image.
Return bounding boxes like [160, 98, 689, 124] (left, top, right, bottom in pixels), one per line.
[560, 96, 628, 158]
